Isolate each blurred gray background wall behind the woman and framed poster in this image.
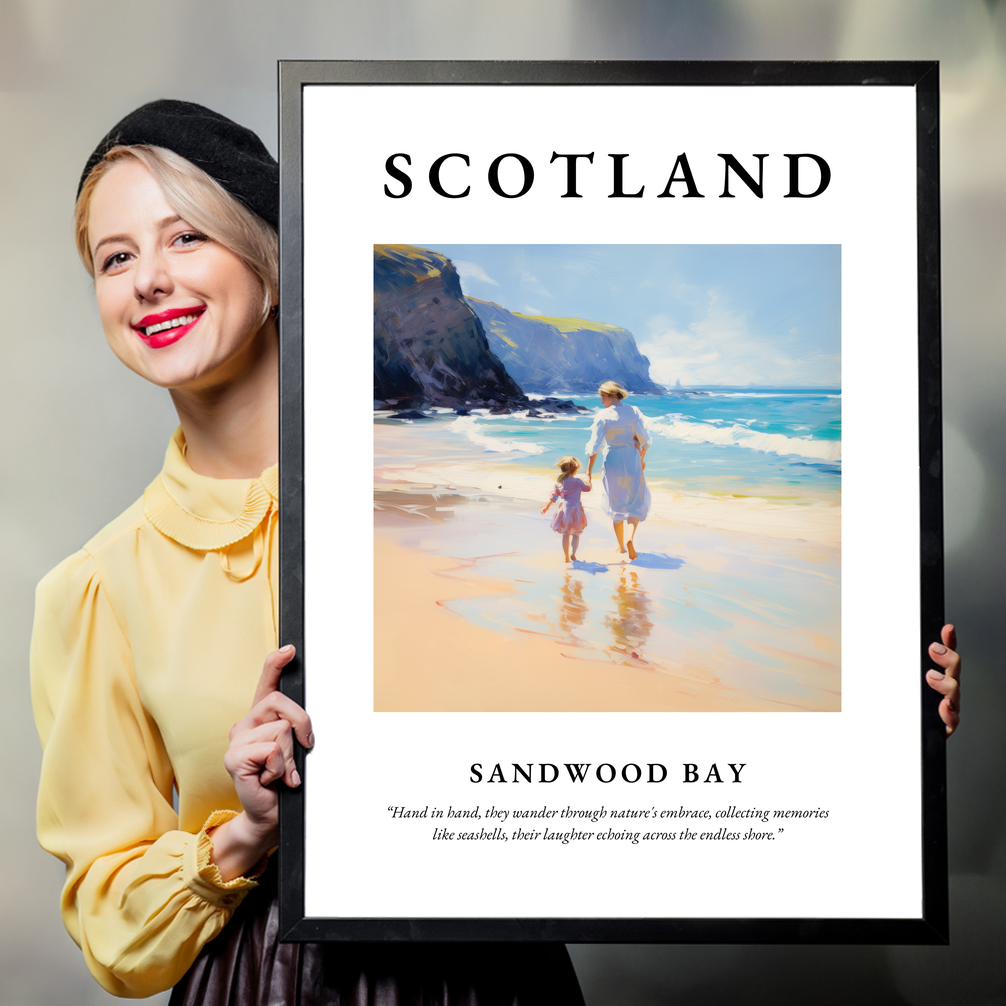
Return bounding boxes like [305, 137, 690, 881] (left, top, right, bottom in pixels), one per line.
[0, 0, 1006, 1006]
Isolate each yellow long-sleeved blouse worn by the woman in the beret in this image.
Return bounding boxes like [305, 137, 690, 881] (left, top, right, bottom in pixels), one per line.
[31, 430, 279, 997]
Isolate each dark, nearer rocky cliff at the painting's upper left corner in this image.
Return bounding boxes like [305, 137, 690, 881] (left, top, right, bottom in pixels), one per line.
[374, 244, 527, 409]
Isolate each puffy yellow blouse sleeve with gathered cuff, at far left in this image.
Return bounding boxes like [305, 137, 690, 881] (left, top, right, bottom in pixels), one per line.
[31, 551, 265, 997]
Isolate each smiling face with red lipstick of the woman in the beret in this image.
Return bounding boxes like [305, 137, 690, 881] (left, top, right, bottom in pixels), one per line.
[88, 158, 275, 392]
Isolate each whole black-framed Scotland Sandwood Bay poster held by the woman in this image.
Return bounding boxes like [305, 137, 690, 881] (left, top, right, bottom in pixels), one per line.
[281, 63, 946, 942]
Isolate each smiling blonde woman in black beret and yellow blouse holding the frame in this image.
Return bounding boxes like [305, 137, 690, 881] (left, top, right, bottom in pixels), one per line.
[31, 101, 582, 1006]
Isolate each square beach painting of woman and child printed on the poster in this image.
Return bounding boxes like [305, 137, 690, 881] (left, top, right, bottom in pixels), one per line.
[374, 244, 841, 711]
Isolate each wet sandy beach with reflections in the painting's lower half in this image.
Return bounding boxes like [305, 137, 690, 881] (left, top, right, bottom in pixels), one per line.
[374, 423, 841, 711]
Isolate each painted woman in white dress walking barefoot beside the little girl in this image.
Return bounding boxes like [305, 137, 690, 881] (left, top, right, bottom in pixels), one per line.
[586, 380, 650, 559]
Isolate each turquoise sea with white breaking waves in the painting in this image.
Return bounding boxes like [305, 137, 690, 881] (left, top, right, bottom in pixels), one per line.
[375, 386, 842, 495]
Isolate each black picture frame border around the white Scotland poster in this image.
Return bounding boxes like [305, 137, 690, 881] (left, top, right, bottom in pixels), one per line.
[279, 61, 949, 944]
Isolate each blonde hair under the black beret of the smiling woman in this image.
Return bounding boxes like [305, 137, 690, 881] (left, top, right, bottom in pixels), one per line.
[73, 145, 280, 323]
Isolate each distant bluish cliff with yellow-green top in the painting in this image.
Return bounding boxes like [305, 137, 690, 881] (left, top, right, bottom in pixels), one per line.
[468, 297, 663, 394]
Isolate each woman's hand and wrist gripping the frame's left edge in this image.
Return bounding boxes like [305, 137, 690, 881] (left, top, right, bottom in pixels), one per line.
[209, 646, 314, 880]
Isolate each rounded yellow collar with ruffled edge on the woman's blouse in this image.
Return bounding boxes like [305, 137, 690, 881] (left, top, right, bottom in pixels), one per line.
[143, 427, 280, 551]
